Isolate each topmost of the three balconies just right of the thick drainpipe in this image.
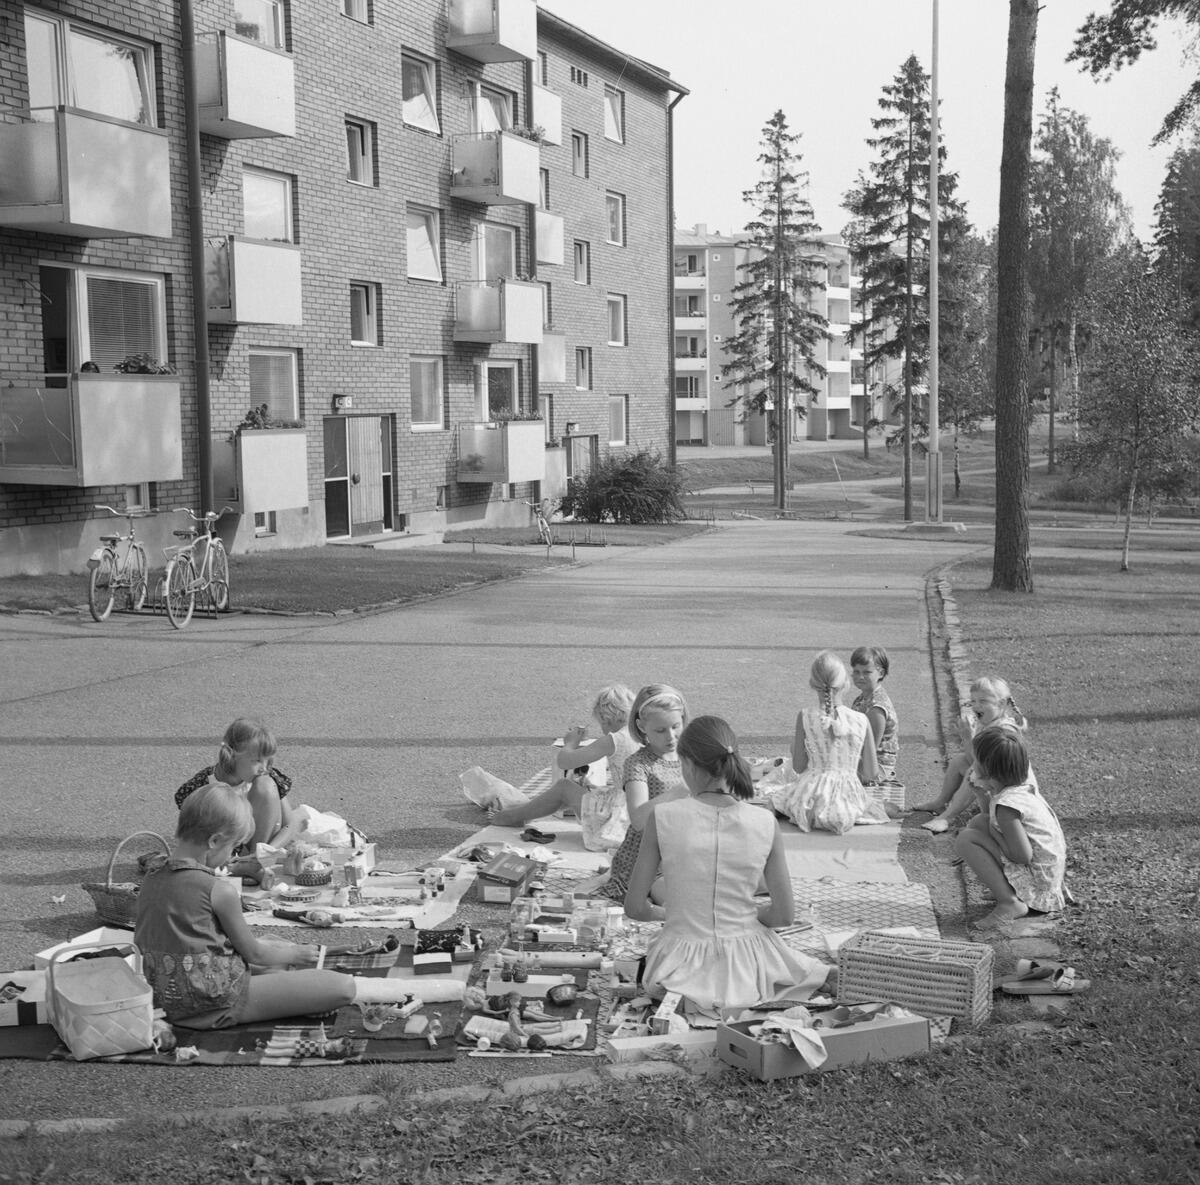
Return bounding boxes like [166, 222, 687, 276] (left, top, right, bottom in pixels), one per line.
[196, 32, 296, 140]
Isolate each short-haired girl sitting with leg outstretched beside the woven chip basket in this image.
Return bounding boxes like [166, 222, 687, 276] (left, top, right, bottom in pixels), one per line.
[133, 784, 453, 1029]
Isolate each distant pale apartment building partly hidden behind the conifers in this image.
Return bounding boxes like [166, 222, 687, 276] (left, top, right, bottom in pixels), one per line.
[674, 223, 884, 445]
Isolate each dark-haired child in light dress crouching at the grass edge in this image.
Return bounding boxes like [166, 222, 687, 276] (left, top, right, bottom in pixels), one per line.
[954, 726, 1067, 930]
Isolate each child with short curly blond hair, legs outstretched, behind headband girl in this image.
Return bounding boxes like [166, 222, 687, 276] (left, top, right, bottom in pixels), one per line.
[488, 684, 637, 852]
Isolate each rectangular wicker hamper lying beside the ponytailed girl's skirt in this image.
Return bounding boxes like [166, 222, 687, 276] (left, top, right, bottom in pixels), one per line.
[838, 930, 995, 1024]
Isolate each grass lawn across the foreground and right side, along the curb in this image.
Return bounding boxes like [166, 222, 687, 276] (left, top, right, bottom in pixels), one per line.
[0, 555, 1200, 1185]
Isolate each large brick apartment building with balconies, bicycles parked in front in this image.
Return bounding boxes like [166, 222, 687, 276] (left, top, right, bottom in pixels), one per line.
[0, 0, 685, 573]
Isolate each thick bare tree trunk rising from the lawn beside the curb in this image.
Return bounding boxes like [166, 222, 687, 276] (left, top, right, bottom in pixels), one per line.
[991, 0, 1039, 593]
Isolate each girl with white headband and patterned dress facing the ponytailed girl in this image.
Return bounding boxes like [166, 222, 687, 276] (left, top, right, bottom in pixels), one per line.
[596, 682, 688, 901]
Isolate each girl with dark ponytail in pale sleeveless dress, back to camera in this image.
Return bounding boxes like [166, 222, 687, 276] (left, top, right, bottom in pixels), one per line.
[625, 716, 832, 1016]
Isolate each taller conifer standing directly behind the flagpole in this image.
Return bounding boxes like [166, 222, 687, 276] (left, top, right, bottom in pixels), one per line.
[842, 55, 967, 521]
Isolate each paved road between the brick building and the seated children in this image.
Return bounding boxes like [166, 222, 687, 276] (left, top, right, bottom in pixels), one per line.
[0, 522, 964, 1115]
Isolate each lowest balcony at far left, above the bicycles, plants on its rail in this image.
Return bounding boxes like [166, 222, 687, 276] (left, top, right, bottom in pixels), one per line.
[0, 374, 184, 487]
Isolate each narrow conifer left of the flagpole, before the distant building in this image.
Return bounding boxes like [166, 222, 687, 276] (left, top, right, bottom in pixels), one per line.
[721, 110, 828, 510]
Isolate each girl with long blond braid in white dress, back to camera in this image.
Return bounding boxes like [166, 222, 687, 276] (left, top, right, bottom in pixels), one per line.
[770, 650, 888, 835]
